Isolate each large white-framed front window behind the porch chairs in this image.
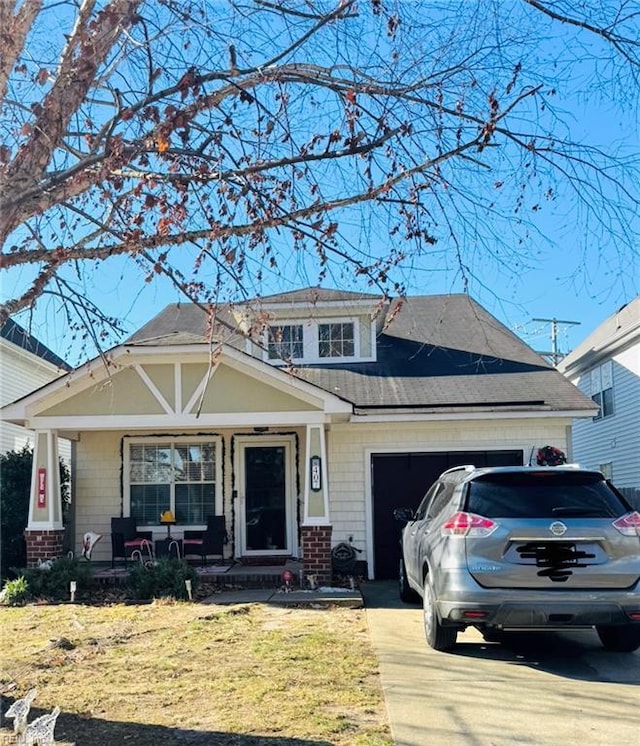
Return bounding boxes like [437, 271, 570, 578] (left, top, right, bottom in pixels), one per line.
[128, 439, 217, 525]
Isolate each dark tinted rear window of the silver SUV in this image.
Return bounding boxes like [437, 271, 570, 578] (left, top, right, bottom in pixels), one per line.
[466, 471, 629, 518]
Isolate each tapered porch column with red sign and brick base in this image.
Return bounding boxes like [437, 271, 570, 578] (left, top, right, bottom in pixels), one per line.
[24, 430, 64, 567]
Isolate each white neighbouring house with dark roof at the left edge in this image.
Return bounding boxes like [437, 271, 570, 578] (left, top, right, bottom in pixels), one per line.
[0, 319, 70, 454]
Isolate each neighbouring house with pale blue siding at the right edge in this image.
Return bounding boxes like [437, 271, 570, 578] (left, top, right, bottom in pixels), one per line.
[558, 296, 640, 507]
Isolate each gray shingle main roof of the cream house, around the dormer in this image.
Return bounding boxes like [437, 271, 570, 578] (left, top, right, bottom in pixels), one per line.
[129, 288, 595, 412]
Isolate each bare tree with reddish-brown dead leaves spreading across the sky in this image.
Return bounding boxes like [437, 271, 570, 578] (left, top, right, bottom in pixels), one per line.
[0, 0, 640, 358]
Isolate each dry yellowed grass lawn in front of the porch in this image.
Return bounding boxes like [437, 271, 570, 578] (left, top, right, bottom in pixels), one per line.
[0, 602, 392, 746]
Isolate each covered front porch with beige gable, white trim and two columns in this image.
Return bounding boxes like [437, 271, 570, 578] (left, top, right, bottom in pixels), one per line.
[5, 344, 351, 582]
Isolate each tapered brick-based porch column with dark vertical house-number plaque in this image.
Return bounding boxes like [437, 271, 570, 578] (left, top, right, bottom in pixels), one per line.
[300, 425, 332, 585]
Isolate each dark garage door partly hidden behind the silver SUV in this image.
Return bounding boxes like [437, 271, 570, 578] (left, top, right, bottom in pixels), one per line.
[371, 451, 523, 580]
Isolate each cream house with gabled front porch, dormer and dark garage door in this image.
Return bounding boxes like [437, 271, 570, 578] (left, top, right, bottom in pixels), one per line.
[3, 288, 596, 579]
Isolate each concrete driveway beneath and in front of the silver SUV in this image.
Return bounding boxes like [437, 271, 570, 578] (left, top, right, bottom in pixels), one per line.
[361, 582, 640, 746]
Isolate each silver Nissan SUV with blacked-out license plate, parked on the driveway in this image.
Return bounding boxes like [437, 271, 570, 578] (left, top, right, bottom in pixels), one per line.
[395, 466, 640, 652]
